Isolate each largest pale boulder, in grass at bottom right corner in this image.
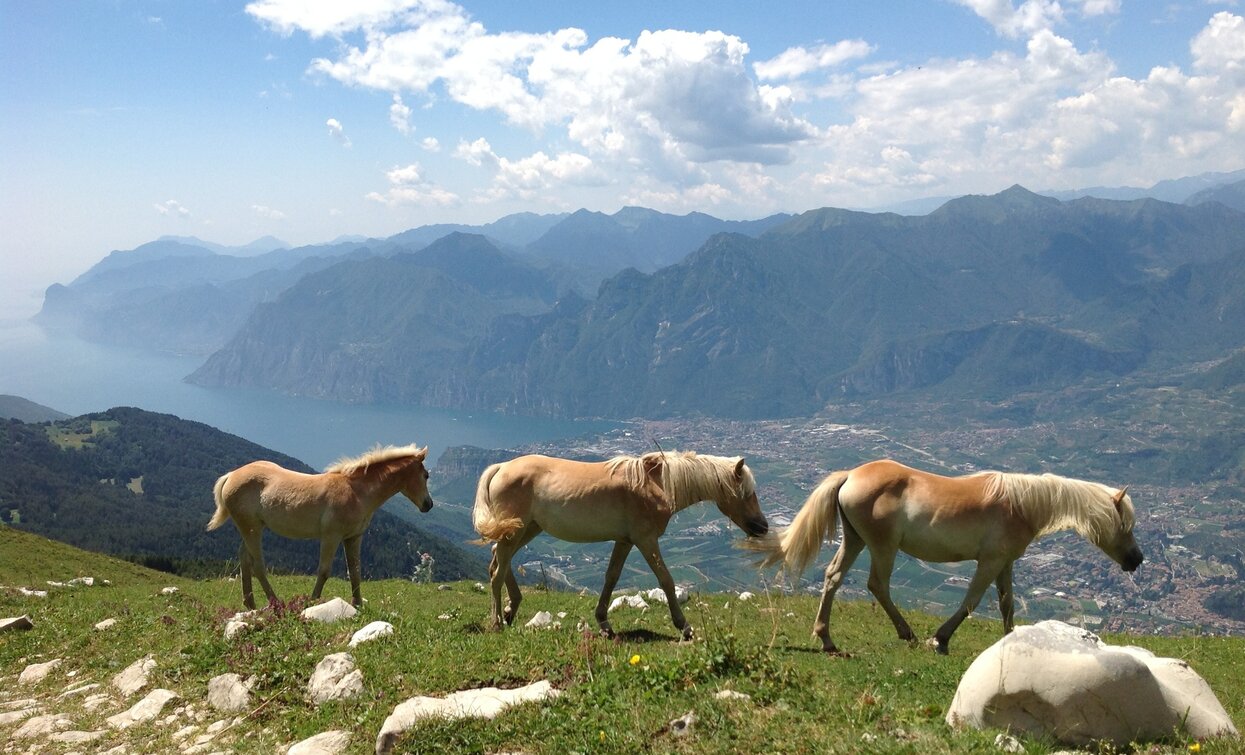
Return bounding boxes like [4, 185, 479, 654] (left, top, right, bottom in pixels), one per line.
[946, 622, 1236, 746]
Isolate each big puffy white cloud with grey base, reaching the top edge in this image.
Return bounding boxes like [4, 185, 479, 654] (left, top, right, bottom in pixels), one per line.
[248, 0, 816, 174]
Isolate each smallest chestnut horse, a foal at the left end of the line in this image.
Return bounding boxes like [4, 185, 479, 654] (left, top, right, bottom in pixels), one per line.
[208, 445, 432, 608]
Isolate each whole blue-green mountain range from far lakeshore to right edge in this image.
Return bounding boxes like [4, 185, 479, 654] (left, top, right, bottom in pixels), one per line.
[190, 187, 1245, 417]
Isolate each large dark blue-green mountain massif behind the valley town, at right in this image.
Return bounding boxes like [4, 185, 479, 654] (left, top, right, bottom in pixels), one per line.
[453, 187, 1245, 417]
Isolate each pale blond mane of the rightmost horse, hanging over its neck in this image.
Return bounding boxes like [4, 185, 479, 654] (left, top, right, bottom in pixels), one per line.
[982, 472, 1135, 543]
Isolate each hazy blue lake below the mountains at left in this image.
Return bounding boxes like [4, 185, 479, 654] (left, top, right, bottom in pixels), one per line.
[0, 319, 616, 468]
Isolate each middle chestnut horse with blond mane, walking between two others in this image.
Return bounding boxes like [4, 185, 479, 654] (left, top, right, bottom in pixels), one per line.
[472, 451, 769, 639]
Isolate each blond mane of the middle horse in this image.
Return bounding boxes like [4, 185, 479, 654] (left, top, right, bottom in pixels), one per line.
[606, 451, 757, 511]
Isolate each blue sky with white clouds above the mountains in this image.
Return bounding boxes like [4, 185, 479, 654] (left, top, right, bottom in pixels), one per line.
[0, 0, 1245, 315]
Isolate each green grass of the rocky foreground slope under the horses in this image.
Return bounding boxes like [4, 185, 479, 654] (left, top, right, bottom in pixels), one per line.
[0, 529, 1245, 754]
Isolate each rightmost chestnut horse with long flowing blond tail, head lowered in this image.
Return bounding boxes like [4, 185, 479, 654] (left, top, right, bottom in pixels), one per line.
[743, 460, 1144, 655]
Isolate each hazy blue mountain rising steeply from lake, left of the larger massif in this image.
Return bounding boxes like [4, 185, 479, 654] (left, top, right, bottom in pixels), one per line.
[189, 233, 557, 405]
